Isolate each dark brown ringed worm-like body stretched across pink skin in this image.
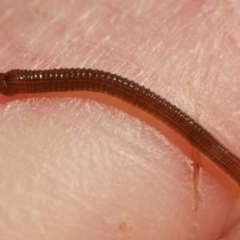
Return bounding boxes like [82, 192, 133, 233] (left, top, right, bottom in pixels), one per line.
[0, 69, 240, 186]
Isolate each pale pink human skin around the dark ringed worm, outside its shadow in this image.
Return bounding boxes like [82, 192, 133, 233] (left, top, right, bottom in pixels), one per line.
[0, 0, 240, 240]
